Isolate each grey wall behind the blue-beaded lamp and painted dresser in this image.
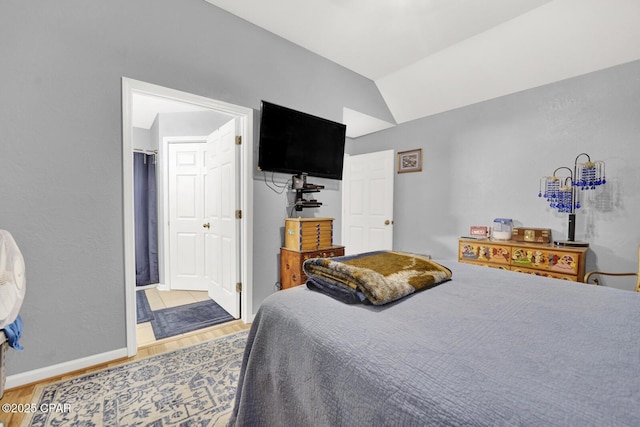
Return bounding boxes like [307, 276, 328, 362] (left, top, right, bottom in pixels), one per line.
[347, 62, 640, 289]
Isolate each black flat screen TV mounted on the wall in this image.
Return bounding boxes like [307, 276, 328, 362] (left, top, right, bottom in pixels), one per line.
[258, 101, 347, 179]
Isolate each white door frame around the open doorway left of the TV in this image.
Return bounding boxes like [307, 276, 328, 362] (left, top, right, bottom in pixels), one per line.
[122, 77, 254, 357]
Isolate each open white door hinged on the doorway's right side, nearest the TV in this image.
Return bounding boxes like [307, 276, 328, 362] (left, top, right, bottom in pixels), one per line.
[205, 120, 240, 318]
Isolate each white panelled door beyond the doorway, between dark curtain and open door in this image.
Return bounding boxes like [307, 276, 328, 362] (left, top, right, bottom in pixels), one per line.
[168, 142, 207, 291]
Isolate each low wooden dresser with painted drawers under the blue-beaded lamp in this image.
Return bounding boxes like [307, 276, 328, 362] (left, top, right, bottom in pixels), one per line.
[458, 238, 589, 282]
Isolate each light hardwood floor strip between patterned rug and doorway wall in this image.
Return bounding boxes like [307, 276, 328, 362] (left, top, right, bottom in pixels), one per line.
[0, 320, 251, 427]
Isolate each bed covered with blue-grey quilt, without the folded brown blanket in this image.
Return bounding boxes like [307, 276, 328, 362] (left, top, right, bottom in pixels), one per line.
[229, 261, 640, 426]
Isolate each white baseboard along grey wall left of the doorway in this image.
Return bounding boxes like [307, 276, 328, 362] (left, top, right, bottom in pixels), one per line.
[5, 348, 127, 390]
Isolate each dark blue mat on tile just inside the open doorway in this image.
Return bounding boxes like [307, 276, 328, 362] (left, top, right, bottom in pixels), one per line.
[151, 300, 234, 340]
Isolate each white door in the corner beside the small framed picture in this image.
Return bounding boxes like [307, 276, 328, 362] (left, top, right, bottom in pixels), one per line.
[342, 150, 394, 254]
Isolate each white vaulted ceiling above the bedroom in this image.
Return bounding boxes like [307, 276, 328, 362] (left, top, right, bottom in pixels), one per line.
[205, 0, 640, 137]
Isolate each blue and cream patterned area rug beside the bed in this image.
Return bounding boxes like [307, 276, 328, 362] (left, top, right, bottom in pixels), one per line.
[21, 330, 248, 427]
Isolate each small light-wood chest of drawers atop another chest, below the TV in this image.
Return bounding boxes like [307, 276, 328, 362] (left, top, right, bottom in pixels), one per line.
[284, 218, 333, 251]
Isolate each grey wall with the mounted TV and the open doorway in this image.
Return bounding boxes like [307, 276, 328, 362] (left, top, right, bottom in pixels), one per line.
[0, 0, 391, 376]
